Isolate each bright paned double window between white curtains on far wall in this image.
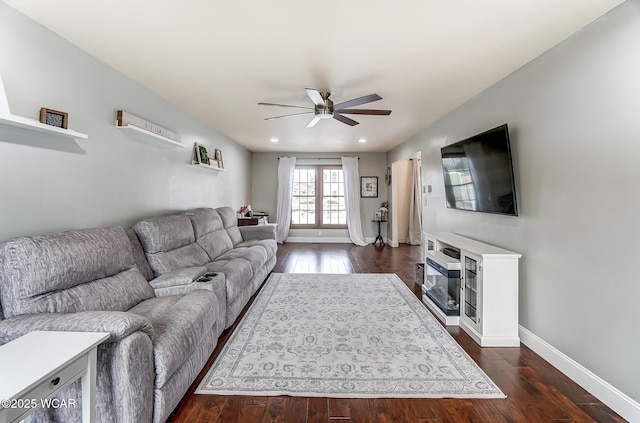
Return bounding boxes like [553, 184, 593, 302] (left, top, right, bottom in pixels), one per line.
[291, 166, 347, 228]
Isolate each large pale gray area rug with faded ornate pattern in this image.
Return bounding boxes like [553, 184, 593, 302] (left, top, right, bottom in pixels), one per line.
[196, 273, 504, 398]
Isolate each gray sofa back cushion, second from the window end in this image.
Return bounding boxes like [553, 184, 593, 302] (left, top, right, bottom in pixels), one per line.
[184, 208, 235, 261]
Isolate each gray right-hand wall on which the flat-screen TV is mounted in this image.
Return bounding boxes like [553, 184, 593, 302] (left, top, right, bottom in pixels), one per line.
[389, 0, 640, 401]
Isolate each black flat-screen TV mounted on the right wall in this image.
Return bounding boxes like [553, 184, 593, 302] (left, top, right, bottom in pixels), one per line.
[441, 124, 518, 216]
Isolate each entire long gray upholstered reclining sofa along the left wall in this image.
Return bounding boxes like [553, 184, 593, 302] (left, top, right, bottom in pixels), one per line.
[0, 207, 277, 423]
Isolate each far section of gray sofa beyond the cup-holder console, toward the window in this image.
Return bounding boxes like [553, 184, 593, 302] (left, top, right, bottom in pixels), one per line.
[133, 207, 277, 328]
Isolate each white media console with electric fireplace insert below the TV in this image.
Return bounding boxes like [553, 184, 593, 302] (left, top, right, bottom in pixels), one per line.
[422, 232, 522, 347]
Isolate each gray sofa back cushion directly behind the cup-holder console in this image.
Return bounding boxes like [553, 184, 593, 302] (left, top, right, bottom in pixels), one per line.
[133, 214, 210, 277]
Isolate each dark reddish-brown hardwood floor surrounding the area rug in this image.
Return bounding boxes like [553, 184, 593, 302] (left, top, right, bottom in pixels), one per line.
[169, 244, 626, 423]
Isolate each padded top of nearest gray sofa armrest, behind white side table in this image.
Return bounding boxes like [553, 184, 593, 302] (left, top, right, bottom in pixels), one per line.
[0, 311, 153, 344]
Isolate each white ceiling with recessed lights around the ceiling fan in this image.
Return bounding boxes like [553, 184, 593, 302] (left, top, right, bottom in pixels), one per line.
[4, 0, 623, 152]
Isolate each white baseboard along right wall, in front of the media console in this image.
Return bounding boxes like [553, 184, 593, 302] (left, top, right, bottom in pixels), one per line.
[518, 326, 640, 422]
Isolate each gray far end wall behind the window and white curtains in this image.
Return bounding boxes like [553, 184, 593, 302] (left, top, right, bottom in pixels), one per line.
[251, 153, 387, 242]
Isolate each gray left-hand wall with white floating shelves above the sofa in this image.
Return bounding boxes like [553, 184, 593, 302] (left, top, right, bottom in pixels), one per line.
[0, 3, 251, 241]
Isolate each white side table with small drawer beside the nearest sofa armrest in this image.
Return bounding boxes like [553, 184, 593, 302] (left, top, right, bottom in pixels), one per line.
[0, 331, 109, 423]
